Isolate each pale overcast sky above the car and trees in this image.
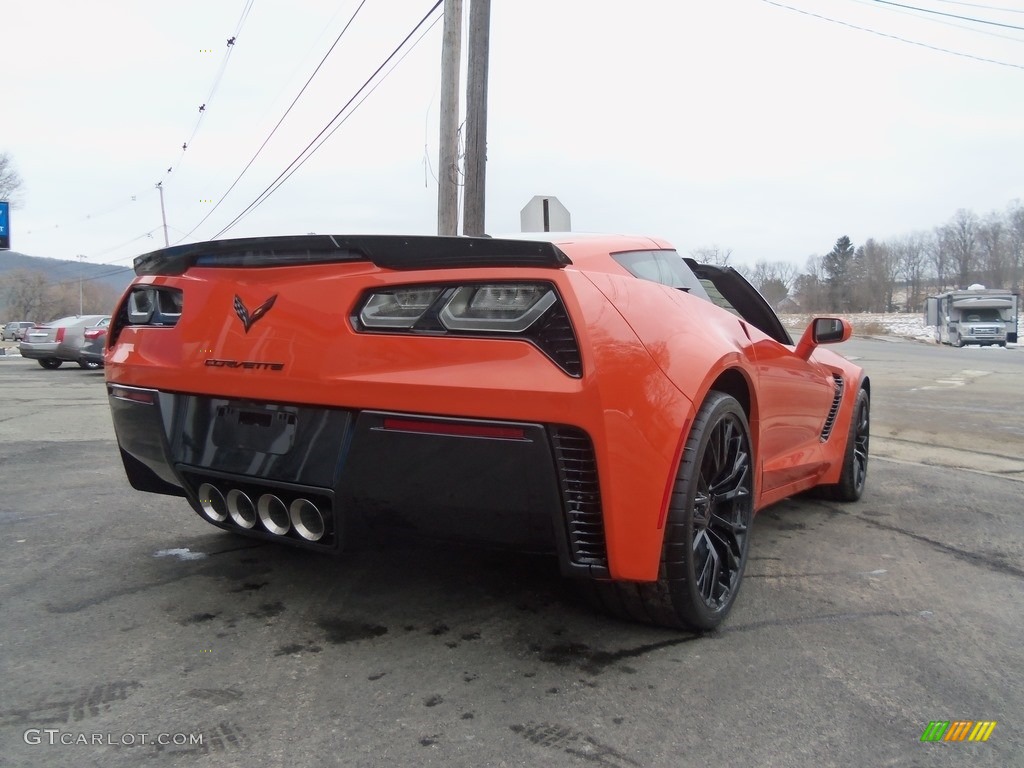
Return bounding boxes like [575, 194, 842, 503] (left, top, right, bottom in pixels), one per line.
[0, 0, 1024, 266]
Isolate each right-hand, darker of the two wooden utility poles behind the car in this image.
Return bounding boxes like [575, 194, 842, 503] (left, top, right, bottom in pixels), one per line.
[462, 0, 490, 237]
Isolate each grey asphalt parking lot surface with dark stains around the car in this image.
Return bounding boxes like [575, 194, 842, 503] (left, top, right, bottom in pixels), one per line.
[0, 339, 1024, 768]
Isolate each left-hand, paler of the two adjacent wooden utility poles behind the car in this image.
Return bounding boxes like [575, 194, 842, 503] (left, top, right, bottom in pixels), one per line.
[437, 0, 462, 234]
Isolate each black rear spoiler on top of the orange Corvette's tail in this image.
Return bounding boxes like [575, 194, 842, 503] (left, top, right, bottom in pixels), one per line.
[134, 234, 572, 275]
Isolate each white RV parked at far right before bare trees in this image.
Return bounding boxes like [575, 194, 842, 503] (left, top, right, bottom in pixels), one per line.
[925, 286, 1020, 347]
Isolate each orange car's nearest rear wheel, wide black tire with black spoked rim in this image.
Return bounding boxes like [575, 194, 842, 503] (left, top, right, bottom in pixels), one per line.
[585, 392, 754, 632]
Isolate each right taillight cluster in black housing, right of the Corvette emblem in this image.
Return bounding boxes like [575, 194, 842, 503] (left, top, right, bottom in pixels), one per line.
[351, 282, 583, 377]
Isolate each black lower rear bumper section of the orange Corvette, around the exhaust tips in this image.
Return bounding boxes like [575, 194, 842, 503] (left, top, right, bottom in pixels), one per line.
[108, 384, 608, 578]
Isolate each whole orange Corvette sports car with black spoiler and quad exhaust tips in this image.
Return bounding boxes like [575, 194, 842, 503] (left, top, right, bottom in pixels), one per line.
[105, 232, 870, 631]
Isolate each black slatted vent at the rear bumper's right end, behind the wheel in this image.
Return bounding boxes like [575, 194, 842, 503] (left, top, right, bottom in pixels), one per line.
[551, 426, 608, 567]
